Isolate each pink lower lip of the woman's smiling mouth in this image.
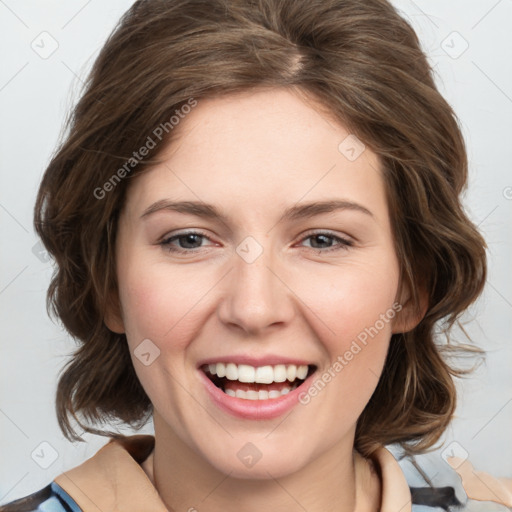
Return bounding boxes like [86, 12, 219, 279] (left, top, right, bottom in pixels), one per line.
[199, 370, 315, 420]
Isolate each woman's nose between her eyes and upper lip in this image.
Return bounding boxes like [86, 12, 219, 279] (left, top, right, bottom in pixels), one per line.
[218, 242, 295, 336]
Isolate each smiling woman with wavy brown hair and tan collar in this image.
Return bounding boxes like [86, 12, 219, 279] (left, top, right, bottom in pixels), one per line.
[1, 0, 486, 512]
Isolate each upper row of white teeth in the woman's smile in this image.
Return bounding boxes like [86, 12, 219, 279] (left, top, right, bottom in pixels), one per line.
[208, 363, 308, 384]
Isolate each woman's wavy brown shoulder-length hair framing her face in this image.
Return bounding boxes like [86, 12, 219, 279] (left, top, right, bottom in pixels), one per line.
[34, 0, 486, 455]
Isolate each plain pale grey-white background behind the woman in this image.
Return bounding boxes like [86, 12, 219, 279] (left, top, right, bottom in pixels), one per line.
[0, 0, 512, 503]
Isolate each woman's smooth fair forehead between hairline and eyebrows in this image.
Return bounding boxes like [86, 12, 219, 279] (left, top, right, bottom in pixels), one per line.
[122, 89, 386, 222]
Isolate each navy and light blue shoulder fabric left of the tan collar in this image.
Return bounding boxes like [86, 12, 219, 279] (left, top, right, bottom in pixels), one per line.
[0, 482, 82, 512]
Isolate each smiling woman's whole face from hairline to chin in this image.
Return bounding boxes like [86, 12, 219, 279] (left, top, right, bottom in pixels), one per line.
[106, 89, 412, 478]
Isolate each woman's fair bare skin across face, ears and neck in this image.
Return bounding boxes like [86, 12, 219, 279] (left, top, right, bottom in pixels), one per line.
[105, 89, 419, 512]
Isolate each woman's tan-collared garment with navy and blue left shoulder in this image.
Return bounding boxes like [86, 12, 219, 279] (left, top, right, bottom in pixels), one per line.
[0, 435, 504, 512]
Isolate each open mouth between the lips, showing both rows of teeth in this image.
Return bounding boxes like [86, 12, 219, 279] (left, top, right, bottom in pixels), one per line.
[201, 363, 316, 400]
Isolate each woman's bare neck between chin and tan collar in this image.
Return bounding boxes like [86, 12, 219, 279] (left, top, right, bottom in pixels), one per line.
[143, 418, 381, 512]
